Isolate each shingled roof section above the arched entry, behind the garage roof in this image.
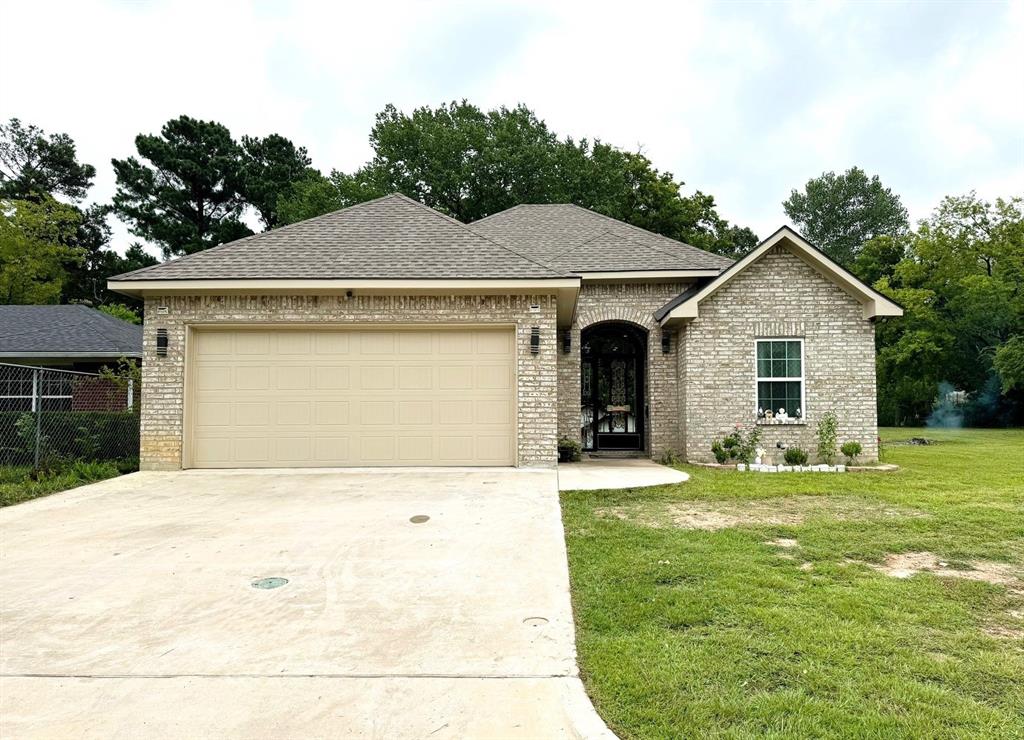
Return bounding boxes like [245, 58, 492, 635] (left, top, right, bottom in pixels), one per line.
[469, 204, 732, 273]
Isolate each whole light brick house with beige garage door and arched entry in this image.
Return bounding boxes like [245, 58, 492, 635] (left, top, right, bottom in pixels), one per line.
[110, 194, 901, 469]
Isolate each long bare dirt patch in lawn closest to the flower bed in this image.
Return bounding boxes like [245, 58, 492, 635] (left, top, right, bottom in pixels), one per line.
[595, 495, 927, 531]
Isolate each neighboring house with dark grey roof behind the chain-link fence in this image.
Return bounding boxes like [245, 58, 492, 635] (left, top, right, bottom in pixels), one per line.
[0, 305, 142, 411]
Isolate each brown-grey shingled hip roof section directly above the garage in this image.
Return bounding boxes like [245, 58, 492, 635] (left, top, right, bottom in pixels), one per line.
[117, 193, 568, 281]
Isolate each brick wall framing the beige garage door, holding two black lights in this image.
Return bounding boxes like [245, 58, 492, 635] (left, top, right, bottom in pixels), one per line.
[140, 295, 557, 470]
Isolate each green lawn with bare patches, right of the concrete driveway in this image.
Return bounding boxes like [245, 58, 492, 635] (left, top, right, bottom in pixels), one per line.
[562, 429, 1024, 738]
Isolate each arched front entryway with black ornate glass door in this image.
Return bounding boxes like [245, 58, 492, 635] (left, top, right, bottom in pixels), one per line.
[580, 321, 647, 451]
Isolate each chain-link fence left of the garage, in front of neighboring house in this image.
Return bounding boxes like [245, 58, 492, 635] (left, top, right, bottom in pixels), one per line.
[0, 363, 139, 469]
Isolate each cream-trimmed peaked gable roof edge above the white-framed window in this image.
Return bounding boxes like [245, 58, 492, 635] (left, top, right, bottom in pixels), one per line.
[654, 226, 903, 325]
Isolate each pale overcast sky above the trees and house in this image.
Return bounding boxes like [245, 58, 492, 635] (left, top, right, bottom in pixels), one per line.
[0, 0, 1024, 255]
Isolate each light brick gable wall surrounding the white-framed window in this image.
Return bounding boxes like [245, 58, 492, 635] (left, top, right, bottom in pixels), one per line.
[678, 247, 879, 463]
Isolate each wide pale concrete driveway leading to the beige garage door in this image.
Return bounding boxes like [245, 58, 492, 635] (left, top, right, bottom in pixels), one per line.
[0, 469, 607, 738]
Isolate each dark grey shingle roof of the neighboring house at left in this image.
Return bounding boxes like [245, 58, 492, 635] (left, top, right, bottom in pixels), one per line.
[0, 306, 142, 357]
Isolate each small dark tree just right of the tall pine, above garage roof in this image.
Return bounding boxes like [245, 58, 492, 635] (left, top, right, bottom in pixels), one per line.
[242, 134, 318, 228]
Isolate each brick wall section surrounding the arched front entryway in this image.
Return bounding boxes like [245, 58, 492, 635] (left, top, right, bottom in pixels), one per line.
[558, 282, 688, 459]
